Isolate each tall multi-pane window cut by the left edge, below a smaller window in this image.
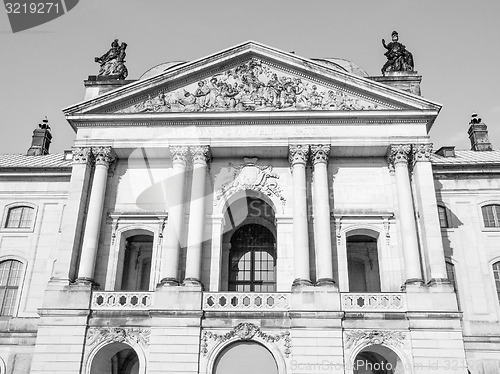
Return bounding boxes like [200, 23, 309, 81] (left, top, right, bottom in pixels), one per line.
[0, 260, 23, 316]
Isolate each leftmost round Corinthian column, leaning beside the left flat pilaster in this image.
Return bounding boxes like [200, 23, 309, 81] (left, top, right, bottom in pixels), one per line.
[77, 147, 114, 282]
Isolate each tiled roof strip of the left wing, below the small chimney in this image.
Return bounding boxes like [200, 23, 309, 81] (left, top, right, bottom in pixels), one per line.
[0, 153, 72, 169]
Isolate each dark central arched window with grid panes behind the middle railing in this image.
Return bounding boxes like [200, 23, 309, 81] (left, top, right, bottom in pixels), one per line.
[229, 224, 276, 292]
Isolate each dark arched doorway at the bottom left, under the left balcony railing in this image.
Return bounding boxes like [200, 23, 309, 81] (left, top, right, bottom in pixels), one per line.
[90, 343, 139, 374]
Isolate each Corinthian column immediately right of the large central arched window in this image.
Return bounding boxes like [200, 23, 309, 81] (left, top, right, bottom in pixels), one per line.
[289, 145, 311, 287]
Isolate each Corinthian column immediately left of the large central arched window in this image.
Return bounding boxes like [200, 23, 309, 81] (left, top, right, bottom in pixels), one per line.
[184, 145, 210, 285]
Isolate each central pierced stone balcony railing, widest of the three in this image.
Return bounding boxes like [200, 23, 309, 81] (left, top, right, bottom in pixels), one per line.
[203, 292, 290, 311]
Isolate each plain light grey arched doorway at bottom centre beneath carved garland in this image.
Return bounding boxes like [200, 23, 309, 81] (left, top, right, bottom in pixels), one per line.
[212, 342, 278, 374]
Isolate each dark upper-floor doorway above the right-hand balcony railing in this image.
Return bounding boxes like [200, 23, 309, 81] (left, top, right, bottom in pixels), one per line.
[346, 234, 381, 292]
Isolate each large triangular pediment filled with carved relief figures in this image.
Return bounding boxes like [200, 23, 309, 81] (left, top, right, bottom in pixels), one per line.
[64, 42, 440, 116]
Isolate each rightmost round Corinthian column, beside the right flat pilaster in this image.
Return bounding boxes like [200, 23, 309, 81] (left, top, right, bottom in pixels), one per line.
[389, 144, 422, 285]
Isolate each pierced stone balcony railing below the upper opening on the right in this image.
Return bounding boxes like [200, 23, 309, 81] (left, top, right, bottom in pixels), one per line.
[342, 292, 406, 312]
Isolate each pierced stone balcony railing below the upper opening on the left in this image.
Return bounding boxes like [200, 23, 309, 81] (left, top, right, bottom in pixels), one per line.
[91, 291, 153, 310]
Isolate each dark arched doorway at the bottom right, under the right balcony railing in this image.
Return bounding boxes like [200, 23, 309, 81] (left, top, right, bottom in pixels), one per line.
[353, 345, 405, 374]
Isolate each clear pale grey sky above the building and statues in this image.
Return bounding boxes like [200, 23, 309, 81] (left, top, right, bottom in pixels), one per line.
[0, 0, 500, 153]
